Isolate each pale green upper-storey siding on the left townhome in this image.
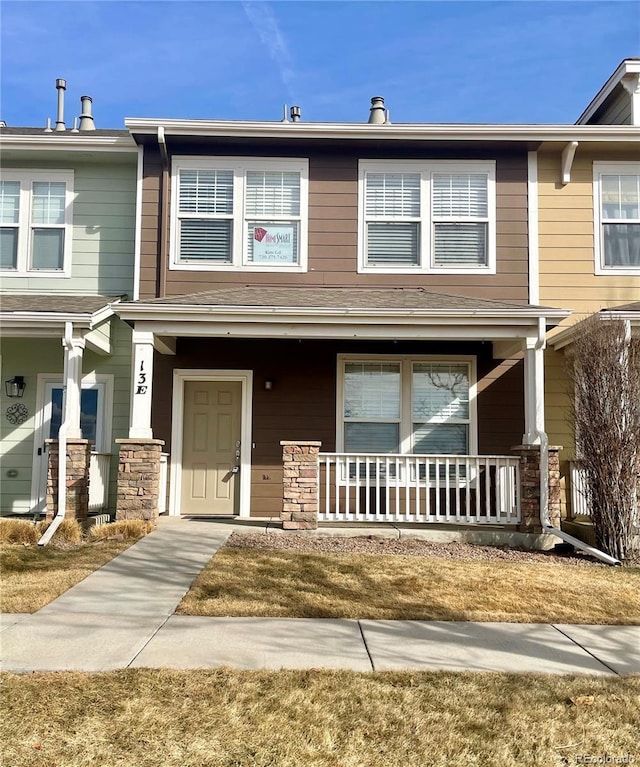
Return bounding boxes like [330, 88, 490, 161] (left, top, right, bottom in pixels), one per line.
[2, 160, 137, 296]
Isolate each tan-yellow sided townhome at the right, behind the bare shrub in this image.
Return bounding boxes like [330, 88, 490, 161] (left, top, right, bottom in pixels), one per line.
[535, 59, 640, 540]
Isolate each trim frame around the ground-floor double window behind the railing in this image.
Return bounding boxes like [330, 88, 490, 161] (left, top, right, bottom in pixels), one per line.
[336, 354, 478, 455]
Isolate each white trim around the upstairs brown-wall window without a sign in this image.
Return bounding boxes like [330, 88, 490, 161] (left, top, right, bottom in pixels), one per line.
[358, 160, 496, 274]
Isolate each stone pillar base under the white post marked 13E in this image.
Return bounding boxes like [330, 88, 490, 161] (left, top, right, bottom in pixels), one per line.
[116, 439, 164, 522]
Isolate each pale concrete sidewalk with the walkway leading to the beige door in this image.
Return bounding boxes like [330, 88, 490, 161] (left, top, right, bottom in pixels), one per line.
[0, 521, 640, 675]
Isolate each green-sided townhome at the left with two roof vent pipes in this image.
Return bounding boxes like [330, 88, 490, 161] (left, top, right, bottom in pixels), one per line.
[0, 80, 139, 518]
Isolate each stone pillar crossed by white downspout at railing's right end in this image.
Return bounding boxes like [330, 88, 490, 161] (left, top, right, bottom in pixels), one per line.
[511, 445, 562, 533]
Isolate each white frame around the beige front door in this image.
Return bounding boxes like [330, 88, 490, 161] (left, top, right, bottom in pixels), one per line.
[169, 368, 253, 517]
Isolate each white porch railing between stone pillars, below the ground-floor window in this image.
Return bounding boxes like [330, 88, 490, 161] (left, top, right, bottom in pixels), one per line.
[318, 453, 520, 524]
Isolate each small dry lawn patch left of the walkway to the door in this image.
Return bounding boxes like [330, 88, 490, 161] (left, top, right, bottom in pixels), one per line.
[0, 540, 134, 613]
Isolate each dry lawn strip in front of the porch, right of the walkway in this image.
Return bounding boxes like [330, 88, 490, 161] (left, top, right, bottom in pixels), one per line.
[177, 547, 640, 624]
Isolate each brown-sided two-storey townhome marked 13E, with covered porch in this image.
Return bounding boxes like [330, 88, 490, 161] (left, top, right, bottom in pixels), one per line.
[114, 97, 608, 545]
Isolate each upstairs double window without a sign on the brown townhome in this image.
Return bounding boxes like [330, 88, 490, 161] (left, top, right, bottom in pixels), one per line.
[359, 160, 495, 273]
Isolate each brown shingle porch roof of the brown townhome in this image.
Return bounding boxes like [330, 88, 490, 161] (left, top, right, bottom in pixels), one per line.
[134, 286, 552, 311]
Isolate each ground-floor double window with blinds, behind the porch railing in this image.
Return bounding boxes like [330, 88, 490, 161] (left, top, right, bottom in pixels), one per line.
[338, 356, 476, 455]
